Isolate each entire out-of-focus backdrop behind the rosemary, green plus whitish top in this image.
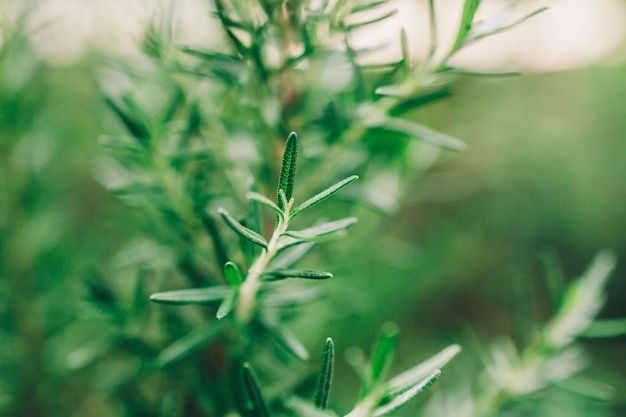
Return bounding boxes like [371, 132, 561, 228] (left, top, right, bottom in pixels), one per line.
[0, 0, 626, 416]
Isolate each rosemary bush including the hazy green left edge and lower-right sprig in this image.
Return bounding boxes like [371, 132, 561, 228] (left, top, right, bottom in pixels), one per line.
[0, 0, 625, 417]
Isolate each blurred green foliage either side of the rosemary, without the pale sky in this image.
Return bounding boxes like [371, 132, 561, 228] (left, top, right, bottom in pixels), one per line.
[0, 0, 626, 416]
